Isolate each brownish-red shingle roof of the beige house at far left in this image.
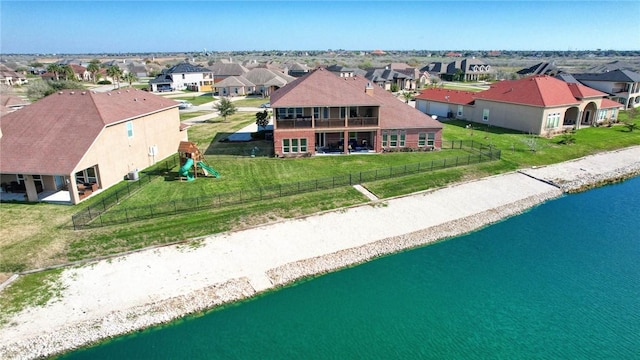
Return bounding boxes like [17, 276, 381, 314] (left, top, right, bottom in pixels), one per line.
[0, 89, 178, 175]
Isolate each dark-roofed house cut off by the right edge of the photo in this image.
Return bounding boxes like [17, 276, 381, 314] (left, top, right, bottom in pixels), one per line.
[571, 69, 640, 109]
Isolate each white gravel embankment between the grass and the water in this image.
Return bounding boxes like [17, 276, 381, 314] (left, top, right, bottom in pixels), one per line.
[0, 147, 640, 359]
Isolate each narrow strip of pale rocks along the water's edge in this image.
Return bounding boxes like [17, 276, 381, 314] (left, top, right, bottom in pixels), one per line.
[0, 190, 561, 359]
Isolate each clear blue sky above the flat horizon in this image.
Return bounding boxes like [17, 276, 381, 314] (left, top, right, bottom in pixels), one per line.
[0, 0, 640, 54]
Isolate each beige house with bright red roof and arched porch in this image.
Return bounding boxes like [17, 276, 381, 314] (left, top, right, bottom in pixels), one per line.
[416, 75, 622, 135]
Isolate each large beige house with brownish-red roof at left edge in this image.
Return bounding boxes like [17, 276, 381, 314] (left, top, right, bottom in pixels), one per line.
[0, 89, 187, 204]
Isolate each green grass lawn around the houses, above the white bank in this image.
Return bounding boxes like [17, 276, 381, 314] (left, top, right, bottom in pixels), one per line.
[0, 108, 640, 286]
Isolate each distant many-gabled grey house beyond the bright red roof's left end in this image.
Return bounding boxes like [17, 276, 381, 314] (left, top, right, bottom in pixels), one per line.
[420, 58, 493, 81]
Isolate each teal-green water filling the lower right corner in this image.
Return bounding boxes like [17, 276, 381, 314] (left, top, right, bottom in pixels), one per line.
[58, 178, 640, 359]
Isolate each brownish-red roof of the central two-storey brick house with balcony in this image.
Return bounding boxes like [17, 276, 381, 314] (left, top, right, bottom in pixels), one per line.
[271, 68, 442, 129]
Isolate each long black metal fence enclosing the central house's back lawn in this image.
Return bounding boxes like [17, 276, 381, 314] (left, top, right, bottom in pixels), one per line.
[72, 141, 501, 229]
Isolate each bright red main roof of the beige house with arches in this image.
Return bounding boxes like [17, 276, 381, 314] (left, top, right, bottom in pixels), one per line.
[475, 75, 580, 107]
